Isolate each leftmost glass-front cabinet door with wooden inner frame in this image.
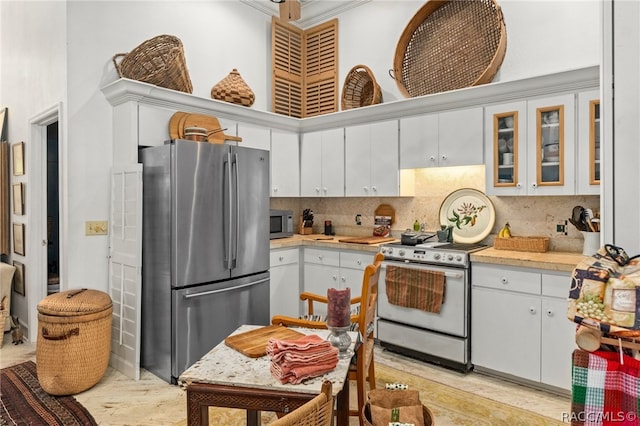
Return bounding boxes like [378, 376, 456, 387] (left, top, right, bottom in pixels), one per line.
[485, 102, 527, 195]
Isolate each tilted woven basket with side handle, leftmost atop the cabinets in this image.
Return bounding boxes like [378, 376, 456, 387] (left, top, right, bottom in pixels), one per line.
[113, 35, 193, 93]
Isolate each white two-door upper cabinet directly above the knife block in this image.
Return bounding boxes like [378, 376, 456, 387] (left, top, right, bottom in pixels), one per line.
[300, 128, 344, 197]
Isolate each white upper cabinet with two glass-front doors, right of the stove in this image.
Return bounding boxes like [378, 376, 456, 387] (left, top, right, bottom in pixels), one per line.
[485, 94, 576, 195]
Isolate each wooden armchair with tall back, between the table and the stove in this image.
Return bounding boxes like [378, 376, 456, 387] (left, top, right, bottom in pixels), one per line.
[271, 253, 384, 426]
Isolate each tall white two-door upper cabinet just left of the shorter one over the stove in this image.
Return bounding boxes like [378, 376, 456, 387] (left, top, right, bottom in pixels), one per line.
[345, 120, 400, 197]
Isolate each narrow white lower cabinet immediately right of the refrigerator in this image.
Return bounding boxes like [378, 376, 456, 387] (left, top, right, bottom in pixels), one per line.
[269, 247, 301, 318]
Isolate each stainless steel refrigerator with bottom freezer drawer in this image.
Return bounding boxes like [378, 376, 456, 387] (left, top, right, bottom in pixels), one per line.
[140, 140, 269, 383]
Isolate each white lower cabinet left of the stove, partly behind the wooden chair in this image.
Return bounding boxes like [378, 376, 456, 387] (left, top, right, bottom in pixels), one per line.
[304, 248, 374, 314]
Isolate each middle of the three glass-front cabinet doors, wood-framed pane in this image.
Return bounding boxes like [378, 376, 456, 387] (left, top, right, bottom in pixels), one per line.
[527, 94, 576, 195]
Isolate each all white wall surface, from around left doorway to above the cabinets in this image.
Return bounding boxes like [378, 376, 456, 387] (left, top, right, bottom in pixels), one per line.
[0, 0, 600, 332]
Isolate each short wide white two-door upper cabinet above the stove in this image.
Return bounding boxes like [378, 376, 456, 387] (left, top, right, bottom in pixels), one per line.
[400, 108, 483, 169]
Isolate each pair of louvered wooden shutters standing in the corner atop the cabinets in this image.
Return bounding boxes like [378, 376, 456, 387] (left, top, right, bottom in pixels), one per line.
[271, 17, 338, 118]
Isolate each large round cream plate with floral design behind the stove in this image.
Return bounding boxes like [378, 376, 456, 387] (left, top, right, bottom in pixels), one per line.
[440, 188, 496, 244]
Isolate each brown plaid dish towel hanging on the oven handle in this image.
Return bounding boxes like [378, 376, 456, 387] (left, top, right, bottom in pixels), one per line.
[385, 265, 446, 314]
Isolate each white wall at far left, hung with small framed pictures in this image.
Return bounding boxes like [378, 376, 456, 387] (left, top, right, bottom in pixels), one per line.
[0, 1, 67, 330]
